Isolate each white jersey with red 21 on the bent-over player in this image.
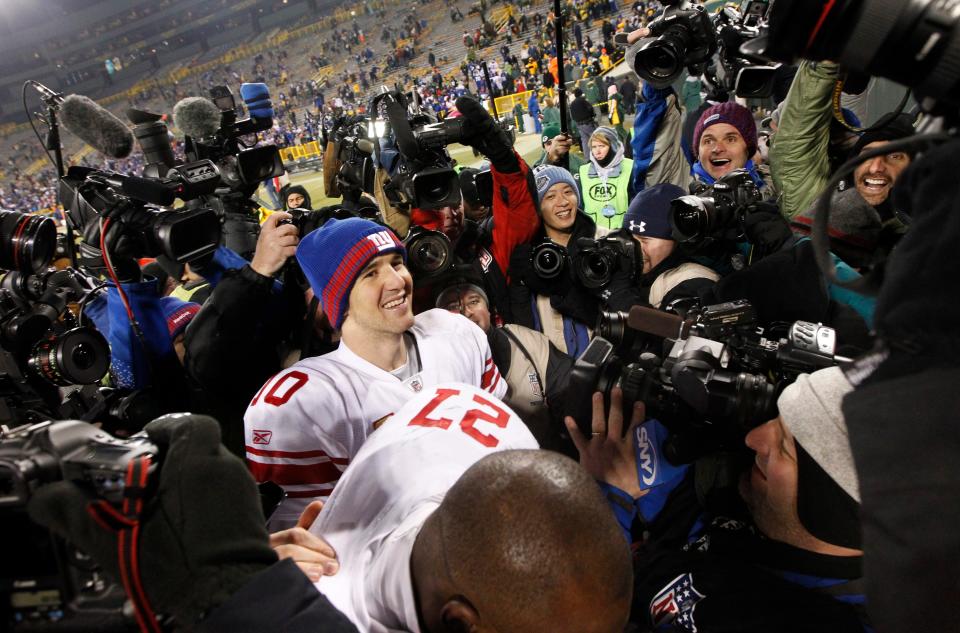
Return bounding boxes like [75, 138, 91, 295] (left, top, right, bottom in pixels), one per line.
[310, 383, 538, 633]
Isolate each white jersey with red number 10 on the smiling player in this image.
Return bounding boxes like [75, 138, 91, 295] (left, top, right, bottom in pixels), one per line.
[244, 309, 507, 530]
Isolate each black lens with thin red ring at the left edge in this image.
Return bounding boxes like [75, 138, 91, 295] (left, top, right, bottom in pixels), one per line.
[0, 210, 57, 275]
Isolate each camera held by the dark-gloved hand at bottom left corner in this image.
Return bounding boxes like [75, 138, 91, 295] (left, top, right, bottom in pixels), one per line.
[0, 420, 158, 631]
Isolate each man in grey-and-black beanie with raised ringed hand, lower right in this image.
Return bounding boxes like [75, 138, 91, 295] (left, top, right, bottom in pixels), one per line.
[566, 367, 868, 633]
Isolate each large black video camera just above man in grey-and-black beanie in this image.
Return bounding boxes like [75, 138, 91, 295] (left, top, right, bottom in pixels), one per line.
[566, 301, 845, 463]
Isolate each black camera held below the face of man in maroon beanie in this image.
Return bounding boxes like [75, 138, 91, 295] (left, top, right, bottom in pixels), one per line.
[670, 169, 763, 248]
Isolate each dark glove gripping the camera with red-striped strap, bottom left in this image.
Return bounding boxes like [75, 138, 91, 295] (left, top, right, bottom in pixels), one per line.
[27, 414, 277, 627]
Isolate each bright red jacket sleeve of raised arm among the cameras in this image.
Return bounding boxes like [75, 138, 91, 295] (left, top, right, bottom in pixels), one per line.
[490, 154, 540, 280]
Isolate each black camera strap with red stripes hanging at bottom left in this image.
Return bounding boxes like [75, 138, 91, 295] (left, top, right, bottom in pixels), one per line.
[87, 455, 161, 633]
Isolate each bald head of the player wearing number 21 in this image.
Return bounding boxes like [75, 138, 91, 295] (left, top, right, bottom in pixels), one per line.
[414, 450, 633, 633]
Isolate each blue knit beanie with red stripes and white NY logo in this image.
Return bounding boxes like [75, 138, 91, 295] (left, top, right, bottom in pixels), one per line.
[297, 218, 407, 329]
